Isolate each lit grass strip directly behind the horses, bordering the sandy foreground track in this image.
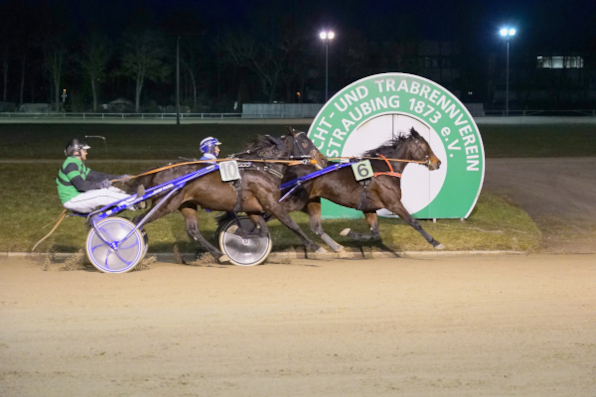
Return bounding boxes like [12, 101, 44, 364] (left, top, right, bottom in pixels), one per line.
[0, 160, 540, 252]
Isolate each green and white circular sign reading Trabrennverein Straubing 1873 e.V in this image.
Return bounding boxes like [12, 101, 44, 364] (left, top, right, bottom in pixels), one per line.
[308, 73, 485, 219]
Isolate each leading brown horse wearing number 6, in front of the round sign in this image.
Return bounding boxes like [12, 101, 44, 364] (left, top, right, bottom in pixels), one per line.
[283, 128, 445, 254]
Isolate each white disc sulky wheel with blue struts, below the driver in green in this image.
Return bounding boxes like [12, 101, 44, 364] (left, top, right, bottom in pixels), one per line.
[86, 217, 147, 273]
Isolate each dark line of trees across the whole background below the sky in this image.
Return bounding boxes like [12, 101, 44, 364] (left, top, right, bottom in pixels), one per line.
[0, 0, 596, 112]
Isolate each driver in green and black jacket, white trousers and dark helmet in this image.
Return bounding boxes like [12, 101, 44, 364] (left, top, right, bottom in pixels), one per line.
[56, 138, 138, 213]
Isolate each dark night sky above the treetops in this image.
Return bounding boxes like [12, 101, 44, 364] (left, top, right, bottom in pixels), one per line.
[15, 0, 596, 50]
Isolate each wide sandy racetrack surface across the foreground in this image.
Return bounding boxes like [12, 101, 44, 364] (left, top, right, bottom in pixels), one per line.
[0, 255, 596, 397]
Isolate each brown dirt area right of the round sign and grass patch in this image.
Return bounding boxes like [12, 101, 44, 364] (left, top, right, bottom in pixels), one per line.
[483, 157, 596, 253]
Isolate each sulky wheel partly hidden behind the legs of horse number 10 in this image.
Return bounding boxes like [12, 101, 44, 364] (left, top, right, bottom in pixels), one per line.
[219, 216, 273, 266]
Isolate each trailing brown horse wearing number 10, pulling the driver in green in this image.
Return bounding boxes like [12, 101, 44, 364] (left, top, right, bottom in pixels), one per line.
[127, 129, 327, 262]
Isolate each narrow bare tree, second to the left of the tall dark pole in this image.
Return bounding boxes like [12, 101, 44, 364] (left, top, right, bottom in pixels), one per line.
[77, 32, 112, 112]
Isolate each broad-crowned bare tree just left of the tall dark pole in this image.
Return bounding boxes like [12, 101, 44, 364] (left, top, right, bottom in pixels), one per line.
[122, 30, 170, 113]
